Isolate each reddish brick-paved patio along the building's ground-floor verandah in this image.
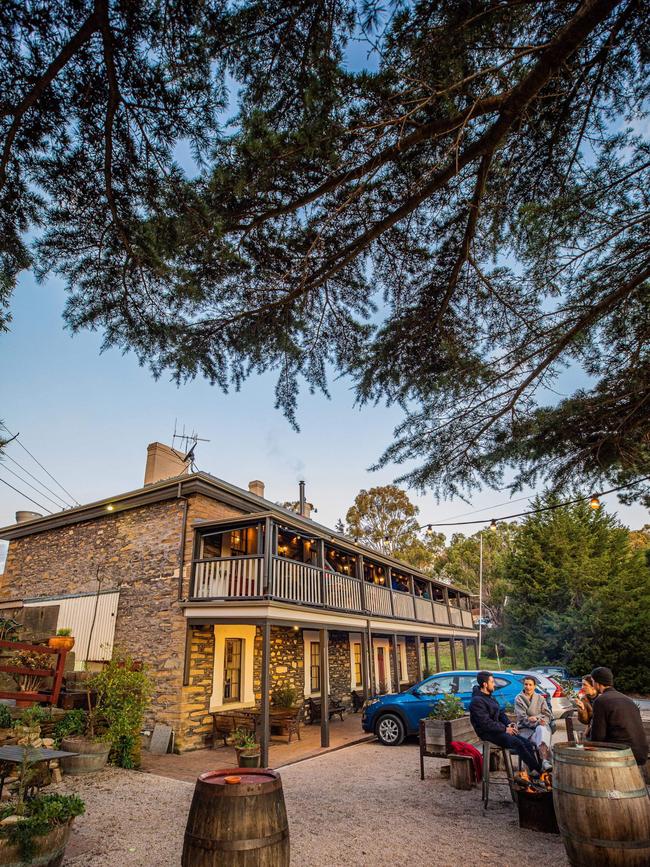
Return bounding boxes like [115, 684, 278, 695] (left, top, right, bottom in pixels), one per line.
[142, 713, 373, 783]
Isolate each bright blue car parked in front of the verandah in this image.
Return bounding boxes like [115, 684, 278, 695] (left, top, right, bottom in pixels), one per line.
[361, 669, 523, 747]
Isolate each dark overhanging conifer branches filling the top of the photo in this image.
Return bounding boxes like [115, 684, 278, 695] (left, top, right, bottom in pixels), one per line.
[0, 0, 650, 495]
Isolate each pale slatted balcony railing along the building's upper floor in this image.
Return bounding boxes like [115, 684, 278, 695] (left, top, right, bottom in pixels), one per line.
[192, 557, 473, 629]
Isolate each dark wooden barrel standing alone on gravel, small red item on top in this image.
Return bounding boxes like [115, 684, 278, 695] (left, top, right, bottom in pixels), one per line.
[181, 768, 289, 867]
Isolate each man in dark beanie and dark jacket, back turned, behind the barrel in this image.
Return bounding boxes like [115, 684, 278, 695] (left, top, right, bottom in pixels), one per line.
[589, 668, 648, 772]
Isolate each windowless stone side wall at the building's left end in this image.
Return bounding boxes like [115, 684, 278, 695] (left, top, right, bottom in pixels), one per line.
[0, 494, 246, 748]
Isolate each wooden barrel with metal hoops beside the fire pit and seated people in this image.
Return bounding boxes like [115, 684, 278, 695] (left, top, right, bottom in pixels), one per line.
[553, 743, 650, 867]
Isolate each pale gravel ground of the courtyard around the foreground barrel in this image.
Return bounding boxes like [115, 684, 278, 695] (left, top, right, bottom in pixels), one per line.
[59, 743, 568, 867]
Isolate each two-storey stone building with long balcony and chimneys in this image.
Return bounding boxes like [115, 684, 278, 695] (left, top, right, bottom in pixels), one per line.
[0, 443, 476, 750]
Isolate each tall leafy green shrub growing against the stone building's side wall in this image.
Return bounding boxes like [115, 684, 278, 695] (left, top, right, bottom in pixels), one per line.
[91, 655, 152, 768]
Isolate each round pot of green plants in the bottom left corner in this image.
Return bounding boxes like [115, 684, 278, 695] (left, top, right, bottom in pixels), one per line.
[0, 747, 84, 867]
